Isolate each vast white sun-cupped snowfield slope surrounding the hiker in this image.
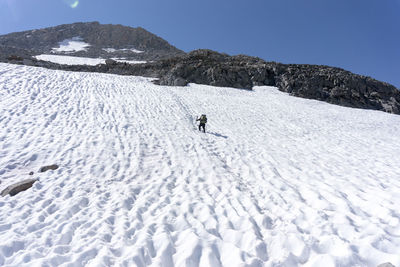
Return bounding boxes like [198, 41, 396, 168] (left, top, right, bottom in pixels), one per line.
[0, 64, 400, 267]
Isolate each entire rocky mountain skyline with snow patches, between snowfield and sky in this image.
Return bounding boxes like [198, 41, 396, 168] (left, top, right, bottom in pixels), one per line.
[0, 22, 400, 114]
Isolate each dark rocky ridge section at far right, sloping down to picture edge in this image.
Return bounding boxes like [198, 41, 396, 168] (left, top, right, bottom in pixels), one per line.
[276, 65, 400, 114]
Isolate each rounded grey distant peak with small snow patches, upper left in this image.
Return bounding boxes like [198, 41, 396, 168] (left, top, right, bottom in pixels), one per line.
[0, 22, 184, 60]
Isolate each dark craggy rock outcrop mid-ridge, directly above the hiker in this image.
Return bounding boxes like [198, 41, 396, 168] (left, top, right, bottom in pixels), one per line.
[159, 50, 275, 89]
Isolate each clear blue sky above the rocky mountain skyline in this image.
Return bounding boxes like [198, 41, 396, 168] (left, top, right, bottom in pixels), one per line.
[0, 0, 400, 88]
